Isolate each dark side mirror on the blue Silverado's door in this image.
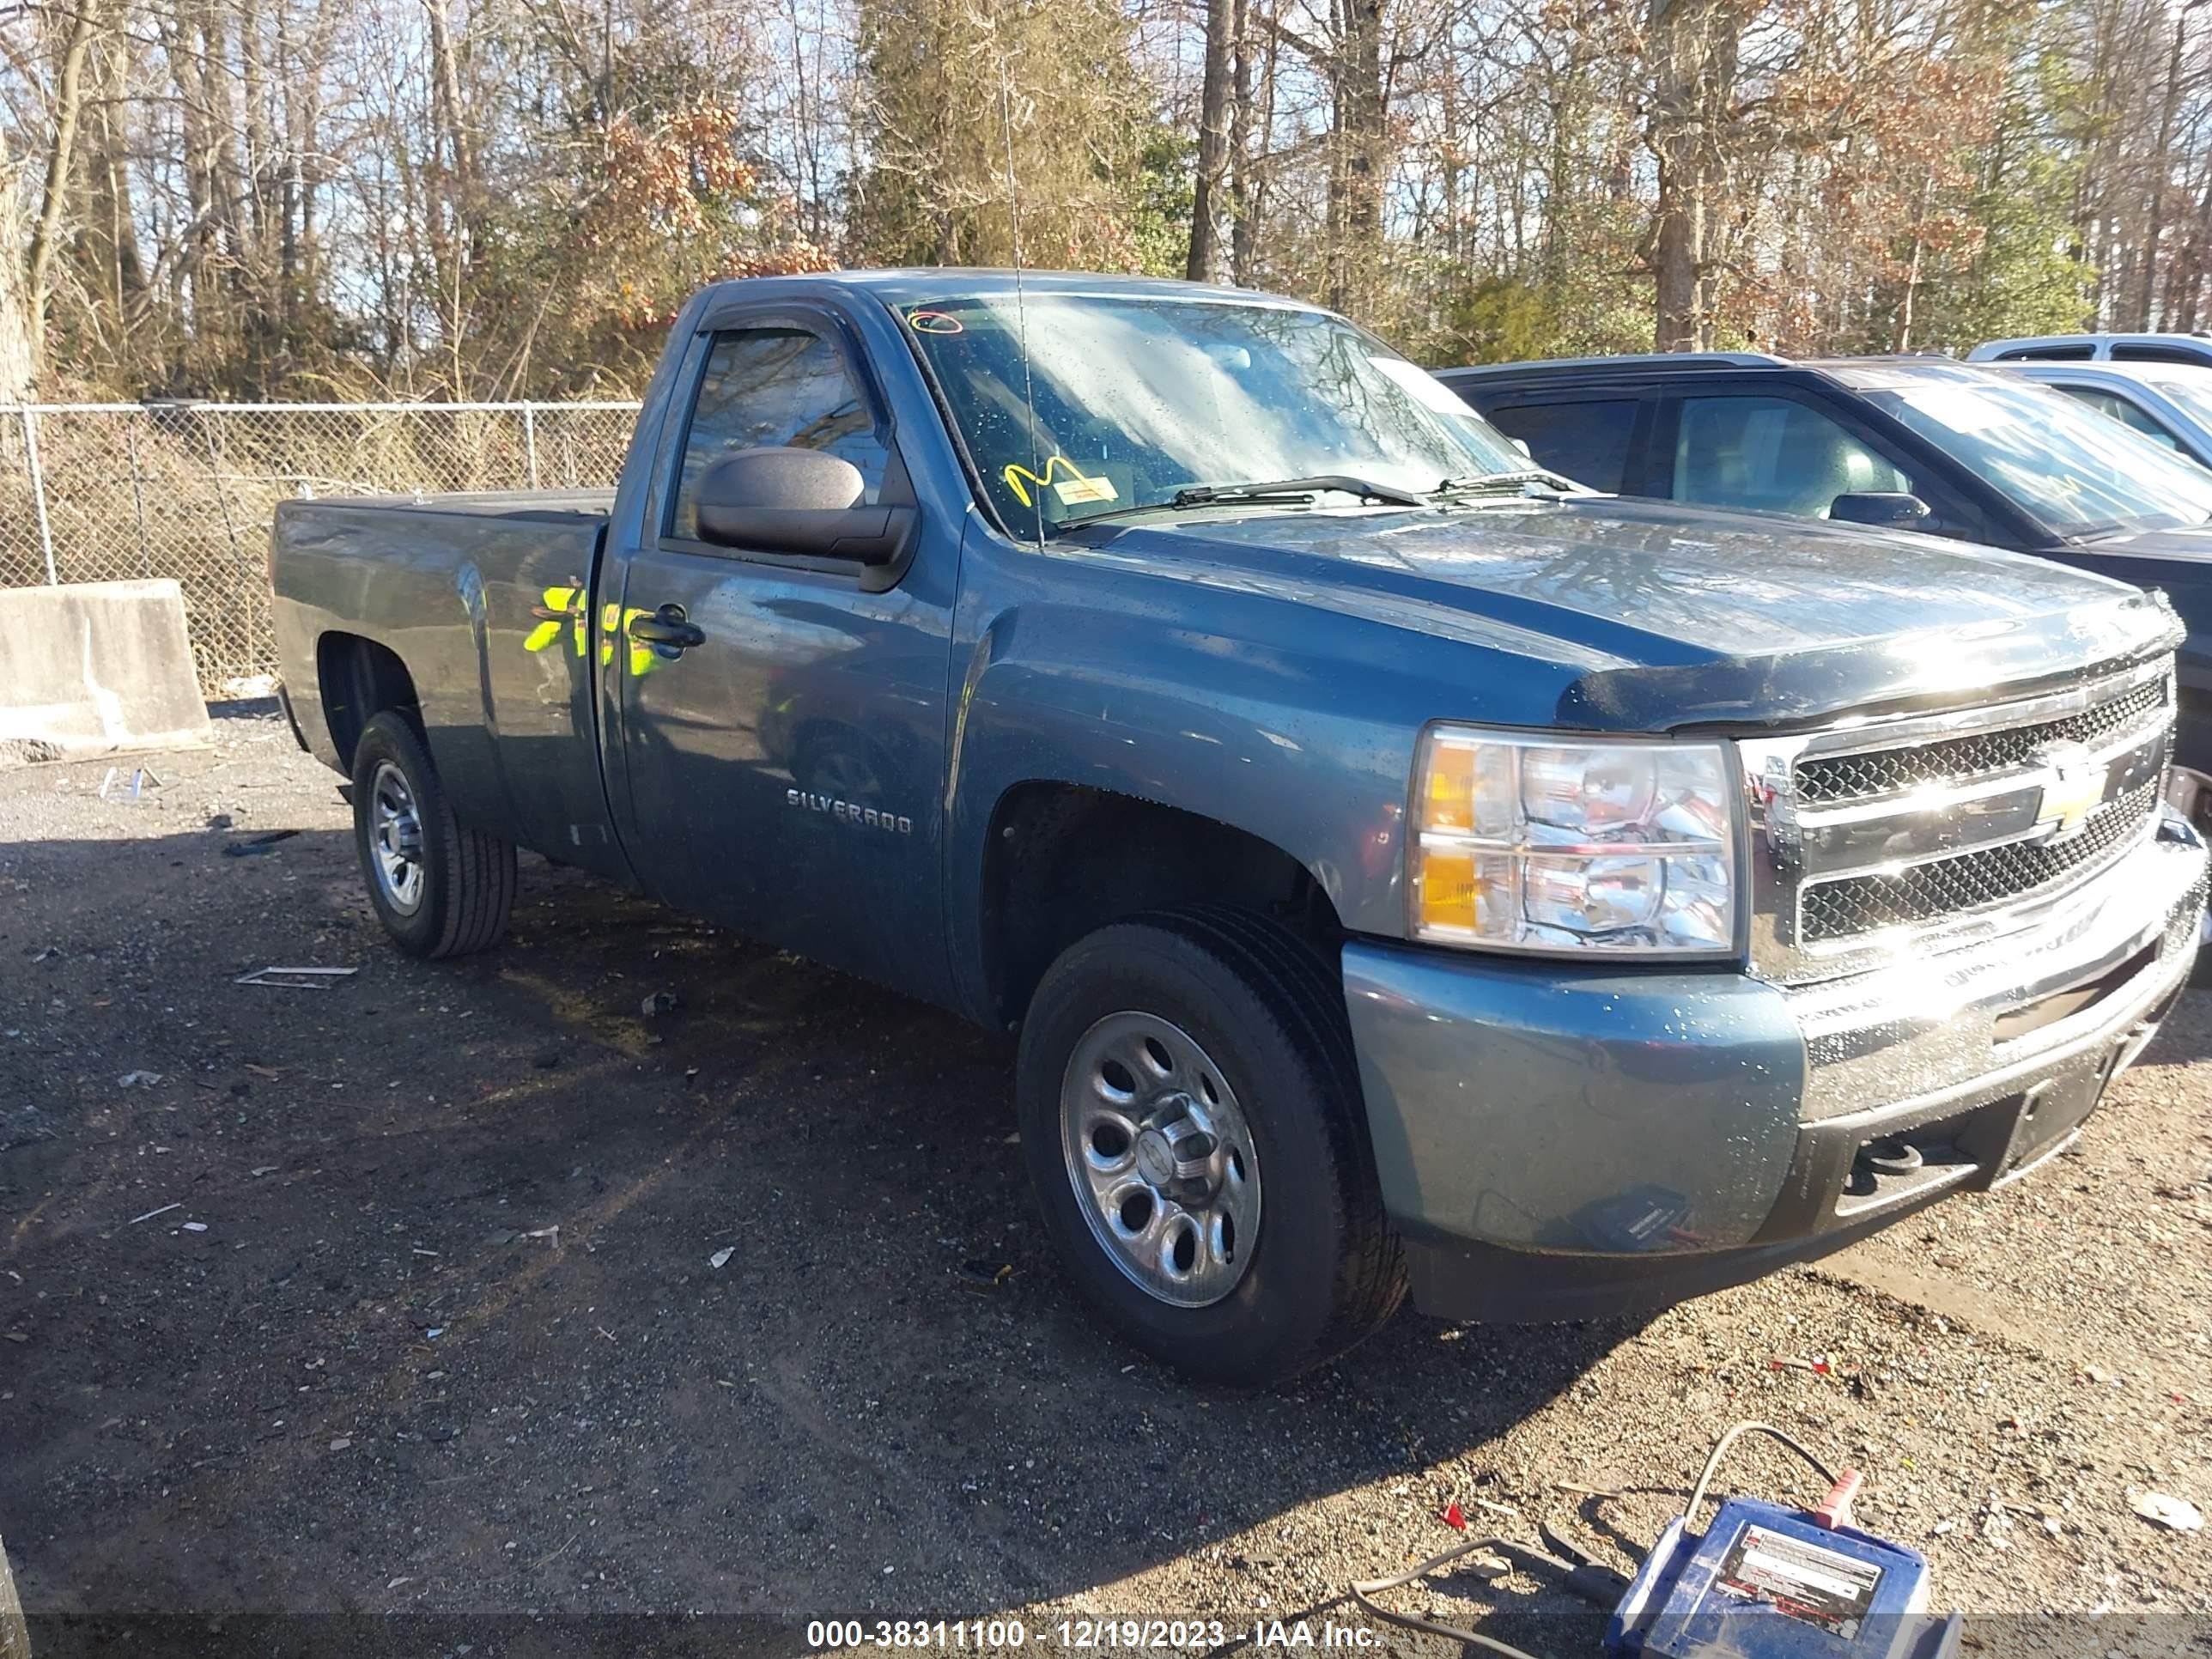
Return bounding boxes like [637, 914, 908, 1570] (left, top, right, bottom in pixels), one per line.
[696, 447, 921, 564]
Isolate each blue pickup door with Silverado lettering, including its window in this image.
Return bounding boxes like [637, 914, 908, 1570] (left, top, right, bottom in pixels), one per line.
[602, 310, 957, 998]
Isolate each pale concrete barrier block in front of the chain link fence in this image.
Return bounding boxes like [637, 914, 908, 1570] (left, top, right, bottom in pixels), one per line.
[0, 581, 215, 761]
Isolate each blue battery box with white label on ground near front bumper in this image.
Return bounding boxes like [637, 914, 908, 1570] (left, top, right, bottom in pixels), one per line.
[1606, 1504, 1962, 1659]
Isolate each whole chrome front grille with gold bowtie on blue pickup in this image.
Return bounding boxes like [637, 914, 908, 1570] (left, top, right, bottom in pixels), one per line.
[1739, 661, 2174, 980]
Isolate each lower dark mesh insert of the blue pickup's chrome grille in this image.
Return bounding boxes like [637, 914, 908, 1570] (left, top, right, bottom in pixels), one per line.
[1798, 781, 2159, 945]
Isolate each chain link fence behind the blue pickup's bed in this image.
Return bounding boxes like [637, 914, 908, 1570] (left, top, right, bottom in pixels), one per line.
[0, 403, 637, 696]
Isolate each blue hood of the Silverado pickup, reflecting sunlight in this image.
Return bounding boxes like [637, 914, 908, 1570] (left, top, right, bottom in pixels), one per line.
[1093, 495, 2185, 730]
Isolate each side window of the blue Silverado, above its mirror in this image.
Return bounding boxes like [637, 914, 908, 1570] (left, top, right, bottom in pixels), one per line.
[668, 327, 890, 540]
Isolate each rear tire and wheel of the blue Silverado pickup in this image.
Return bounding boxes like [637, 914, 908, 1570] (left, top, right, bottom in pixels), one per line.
[354, 710, 515, 960]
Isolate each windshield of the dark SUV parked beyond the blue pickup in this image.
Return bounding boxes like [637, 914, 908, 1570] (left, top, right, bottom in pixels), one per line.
[1850, 372, 2212, 538]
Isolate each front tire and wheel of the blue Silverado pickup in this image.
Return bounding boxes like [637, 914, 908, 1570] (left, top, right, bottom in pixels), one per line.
[1015, 909, 1405, 1387]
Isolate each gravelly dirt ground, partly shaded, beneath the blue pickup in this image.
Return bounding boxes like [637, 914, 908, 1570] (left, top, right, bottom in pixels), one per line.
[0, 710, 2212, 1659]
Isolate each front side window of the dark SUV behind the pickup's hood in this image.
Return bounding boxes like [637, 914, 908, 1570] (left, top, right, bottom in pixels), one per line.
[1674, 396, 1920, 518]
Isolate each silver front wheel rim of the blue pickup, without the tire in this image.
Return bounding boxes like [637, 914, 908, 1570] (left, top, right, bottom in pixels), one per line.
[1060, 1011, 1261, 1307]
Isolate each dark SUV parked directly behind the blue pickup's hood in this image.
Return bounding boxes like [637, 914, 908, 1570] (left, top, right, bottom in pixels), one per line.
[1437, 352, 2212, 772]
